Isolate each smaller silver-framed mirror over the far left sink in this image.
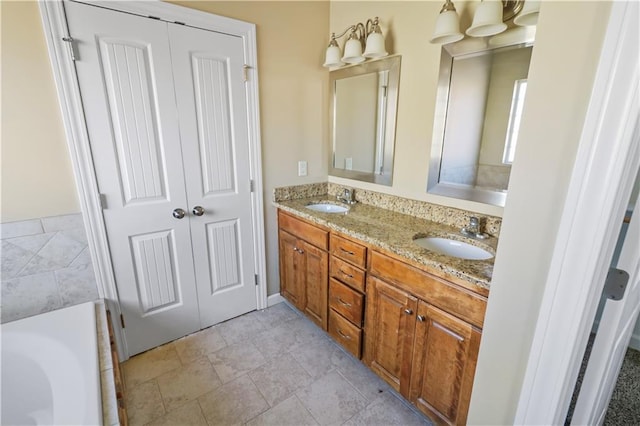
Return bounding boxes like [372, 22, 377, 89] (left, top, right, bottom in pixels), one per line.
[329, 55, 400, 186]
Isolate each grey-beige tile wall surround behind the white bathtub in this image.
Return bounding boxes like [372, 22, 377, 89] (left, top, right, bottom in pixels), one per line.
[0, 214, 98, 322]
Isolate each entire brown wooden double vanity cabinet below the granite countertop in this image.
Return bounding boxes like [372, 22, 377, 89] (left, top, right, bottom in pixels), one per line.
[278, 211, 488, 425]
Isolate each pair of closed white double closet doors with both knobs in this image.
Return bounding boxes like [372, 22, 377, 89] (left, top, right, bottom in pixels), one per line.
[65, 2, 257, 355]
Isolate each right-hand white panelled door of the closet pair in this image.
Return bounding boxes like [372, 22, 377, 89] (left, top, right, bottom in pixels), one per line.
[169, 24, 257, 326]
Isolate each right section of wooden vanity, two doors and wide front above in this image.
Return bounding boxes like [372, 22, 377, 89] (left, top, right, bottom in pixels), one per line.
[364, 251, 486, 424]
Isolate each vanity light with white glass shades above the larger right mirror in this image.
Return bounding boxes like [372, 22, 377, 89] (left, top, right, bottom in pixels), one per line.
[430, 0, 540, 44]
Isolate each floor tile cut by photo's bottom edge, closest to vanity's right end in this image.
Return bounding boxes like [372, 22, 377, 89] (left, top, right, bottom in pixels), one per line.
[345, 393, 432, 426]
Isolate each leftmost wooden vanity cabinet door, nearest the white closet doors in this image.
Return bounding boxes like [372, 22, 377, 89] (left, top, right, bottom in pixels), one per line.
[279, 231, 305, 310]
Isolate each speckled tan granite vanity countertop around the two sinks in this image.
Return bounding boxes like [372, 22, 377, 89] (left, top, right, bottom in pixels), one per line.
[273, 195, 498, 293]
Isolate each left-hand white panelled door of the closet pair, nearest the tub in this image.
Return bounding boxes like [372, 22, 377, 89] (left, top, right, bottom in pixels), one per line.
[65, 2, 200, 355]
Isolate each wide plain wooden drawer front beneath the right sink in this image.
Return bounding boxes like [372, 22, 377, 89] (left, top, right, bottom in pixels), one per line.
[369, 251, 487, 328]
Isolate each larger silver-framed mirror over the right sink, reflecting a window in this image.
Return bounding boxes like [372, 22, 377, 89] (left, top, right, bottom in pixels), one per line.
[427, 27, 535, 206]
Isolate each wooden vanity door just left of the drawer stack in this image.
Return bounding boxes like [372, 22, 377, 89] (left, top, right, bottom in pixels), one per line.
[301, 241, 329, 331]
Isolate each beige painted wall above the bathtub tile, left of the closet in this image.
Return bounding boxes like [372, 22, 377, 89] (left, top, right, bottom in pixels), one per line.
[0, 1, 80, 222]
